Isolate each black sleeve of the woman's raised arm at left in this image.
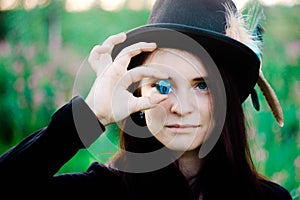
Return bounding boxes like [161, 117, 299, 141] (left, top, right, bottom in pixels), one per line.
[0, 97, 105, 193]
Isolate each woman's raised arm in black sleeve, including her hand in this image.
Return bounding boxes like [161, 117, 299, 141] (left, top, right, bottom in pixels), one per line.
[0, 33, 168, 197]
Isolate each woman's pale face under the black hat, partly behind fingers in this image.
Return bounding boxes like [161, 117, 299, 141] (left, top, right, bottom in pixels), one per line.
[141, 49, 212, 151]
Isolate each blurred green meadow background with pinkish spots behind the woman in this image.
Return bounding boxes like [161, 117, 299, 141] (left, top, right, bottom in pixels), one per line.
[0, 0, 300, 199]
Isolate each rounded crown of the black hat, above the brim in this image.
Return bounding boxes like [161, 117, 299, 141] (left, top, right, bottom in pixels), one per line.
[148, 0, 236, 34]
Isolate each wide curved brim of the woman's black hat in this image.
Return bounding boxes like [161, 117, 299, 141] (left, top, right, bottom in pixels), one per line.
[112, 23, 260, 102]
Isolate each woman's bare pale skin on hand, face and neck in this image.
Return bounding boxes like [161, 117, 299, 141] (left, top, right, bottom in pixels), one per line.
[85, 33, 211, 183]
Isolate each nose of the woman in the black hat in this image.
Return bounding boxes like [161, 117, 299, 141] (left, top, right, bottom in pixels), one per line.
[170, 91, 196, 116]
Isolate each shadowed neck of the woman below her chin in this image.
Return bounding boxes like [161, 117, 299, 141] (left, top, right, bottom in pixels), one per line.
[178, 149, 202, 185]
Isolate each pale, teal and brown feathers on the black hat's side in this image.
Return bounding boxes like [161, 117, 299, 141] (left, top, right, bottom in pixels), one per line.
[224, 4, 284, 127]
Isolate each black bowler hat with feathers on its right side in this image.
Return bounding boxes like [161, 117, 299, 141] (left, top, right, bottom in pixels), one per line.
[112, 0, 283, 126]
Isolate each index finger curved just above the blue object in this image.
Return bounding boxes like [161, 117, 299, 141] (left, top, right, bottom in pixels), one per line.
[121, 67, 169, 88]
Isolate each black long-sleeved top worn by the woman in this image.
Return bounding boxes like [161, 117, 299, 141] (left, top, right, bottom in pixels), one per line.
[0, 97, 292, 200]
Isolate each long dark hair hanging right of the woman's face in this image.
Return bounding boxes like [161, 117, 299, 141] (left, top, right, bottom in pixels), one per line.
[192, 64, 263, 200]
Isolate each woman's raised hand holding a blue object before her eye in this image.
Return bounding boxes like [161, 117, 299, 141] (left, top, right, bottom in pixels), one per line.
[86, 33, 168, 126]
